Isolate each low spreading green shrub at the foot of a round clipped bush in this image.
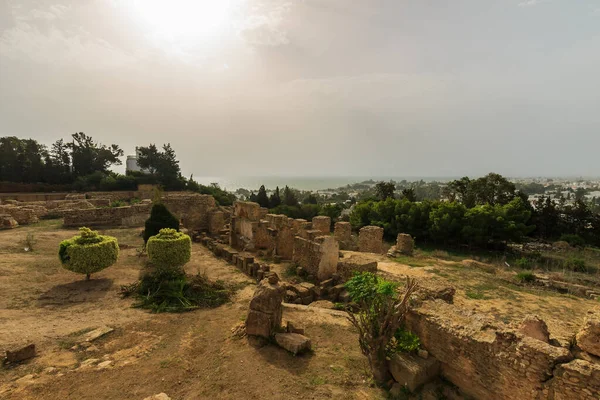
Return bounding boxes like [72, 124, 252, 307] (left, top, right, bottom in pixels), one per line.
[121, 269, 232, 313]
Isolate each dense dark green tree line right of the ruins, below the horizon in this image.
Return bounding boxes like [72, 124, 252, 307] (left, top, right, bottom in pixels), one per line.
[350, 174, 600, 247]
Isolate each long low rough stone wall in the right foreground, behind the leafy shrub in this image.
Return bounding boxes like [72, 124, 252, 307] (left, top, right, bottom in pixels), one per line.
[407, 301, 576, 400]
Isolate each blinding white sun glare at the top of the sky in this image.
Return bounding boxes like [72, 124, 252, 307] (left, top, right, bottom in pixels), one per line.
[128, 0, 239, 42]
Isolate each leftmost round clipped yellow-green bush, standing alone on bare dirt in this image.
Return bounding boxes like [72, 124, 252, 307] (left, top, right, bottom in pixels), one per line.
[58, 227, 119, 279]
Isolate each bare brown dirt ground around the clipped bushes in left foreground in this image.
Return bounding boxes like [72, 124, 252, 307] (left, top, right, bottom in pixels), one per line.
[0, 221, 385, 400]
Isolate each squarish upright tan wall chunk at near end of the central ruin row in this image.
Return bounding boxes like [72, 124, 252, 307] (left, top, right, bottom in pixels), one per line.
[292, 236, 340, 281]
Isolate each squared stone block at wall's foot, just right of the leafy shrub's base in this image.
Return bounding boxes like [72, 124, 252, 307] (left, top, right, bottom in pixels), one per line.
[389, 353, 440, 392]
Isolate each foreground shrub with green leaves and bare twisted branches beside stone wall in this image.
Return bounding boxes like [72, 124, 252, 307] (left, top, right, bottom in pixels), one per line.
[346, 272, 417, 384]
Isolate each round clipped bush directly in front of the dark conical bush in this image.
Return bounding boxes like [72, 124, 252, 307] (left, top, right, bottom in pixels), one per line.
[146, 228, 192, 268]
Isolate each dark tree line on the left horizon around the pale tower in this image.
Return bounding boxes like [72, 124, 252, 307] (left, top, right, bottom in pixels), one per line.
[0, 132, 235, 205]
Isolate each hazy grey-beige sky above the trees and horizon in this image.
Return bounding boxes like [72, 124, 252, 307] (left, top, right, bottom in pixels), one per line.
[0, 0, 600, 176]
